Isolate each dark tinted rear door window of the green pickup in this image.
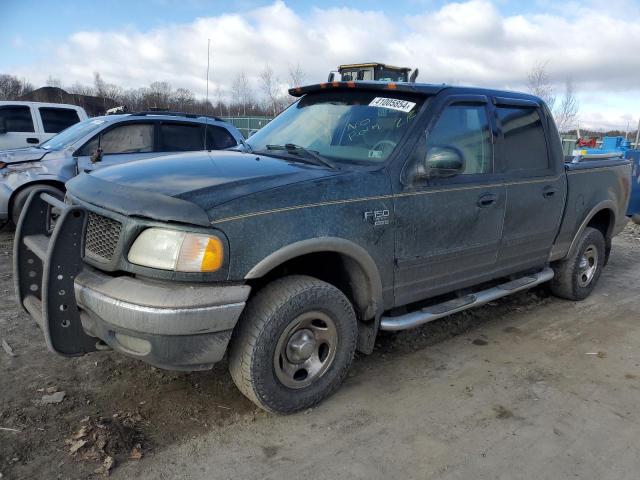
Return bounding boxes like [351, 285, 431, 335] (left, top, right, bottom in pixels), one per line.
[497, 107, 549, 171]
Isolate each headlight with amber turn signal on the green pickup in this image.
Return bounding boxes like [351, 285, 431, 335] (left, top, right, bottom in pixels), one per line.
[129, 228, 224, 272]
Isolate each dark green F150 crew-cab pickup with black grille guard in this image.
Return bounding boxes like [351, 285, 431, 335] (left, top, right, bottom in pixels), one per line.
[14, 82, 631, 413]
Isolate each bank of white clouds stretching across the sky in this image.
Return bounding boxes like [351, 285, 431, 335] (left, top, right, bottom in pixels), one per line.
[6, 0, 640, 127]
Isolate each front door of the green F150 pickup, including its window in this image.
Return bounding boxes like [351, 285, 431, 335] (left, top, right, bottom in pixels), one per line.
[394, 95, 506, 306]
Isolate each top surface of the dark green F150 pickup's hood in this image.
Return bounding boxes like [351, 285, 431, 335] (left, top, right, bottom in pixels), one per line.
[85, 151, 339, 211]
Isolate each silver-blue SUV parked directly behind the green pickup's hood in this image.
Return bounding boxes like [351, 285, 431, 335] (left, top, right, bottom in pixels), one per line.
[0, 112, 243, 223]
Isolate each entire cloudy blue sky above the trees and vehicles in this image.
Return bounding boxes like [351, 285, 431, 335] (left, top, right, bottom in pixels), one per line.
[0, 0, 640, 130]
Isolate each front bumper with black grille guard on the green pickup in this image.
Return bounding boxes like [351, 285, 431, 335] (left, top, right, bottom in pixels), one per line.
[14, 188, 250, 370]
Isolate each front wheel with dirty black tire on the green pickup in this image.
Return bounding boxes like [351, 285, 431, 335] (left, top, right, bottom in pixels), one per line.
[229, 275, 358, 413]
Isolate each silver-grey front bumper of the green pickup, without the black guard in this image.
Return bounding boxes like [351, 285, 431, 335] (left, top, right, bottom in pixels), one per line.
[74, 267, 250, 370]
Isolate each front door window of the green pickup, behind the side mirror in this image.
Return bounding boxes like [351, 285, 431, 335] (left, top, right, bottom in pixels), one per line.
[427, 104, 493, 175]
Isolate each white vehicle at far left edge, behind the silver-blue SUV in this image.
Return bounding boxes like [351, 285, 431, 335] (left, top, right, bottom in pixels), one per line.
[0, 101, 87, 150]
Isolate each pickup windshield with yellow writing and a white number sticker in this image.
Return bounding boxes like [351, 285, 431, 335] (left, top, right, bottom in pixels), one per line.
[247, 91, 424, 163]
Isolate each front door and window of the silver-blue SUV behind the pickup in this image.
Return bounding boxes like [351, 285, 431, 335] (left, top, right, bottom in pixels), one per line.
[76, 122, 158, 173]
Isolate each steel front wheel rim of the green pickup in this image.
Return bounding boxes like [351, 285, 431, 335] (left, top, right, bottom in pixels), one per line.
[273, 311, 338, 389]
